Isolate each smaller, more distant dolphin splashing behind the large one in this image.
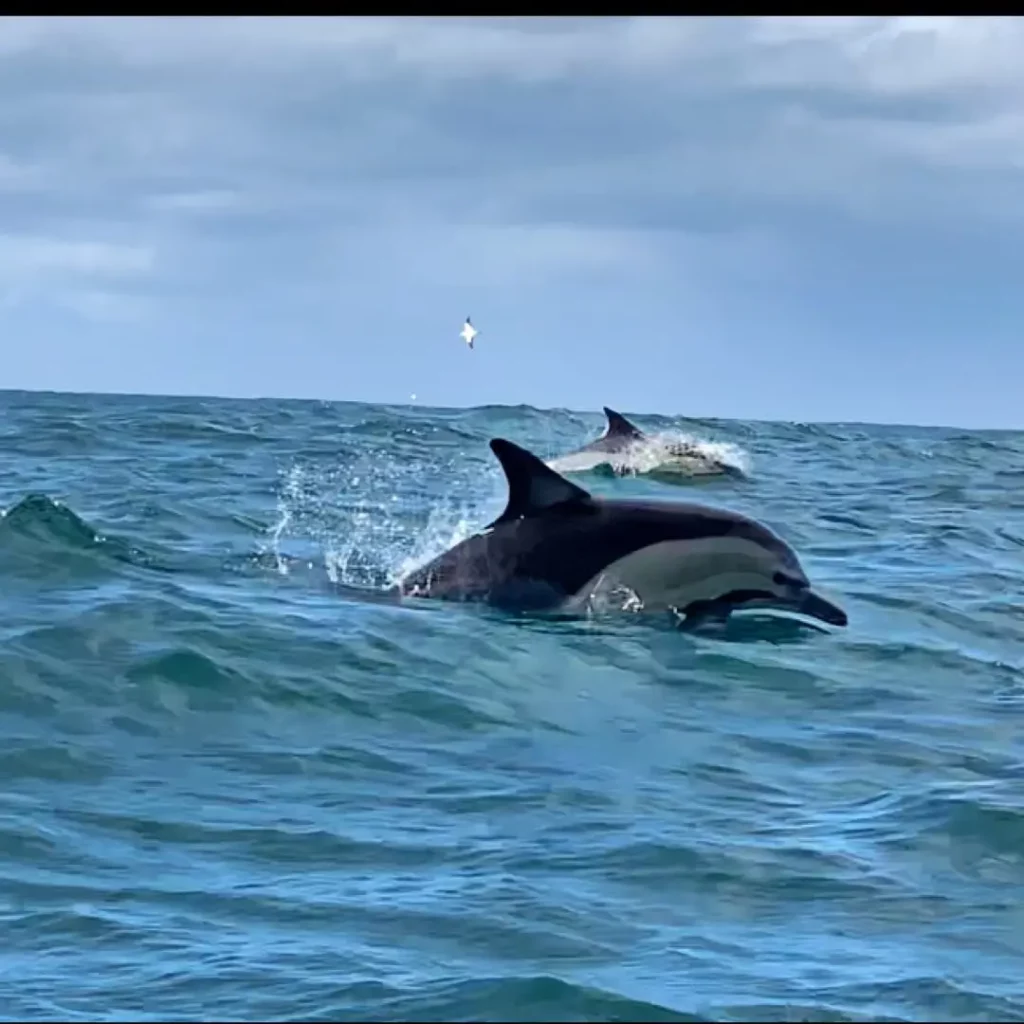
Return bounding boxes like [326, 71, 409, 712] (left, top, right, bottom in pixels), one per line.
[549, 406, 743, 478]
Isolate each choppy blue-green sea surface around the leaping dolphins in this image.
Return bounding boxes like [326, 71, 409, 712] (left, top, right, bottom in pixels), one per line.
[0, 392, 1024, 1021]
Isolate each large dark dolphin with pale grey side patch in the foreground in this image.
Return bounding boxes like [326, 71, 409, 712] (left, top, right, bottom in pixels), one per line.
[396, 437, 847, 626]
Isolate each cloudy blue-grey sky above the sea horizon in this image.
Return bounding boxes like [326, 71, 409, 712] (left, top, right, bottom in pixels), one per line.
[0, 16, 1024, 428]
